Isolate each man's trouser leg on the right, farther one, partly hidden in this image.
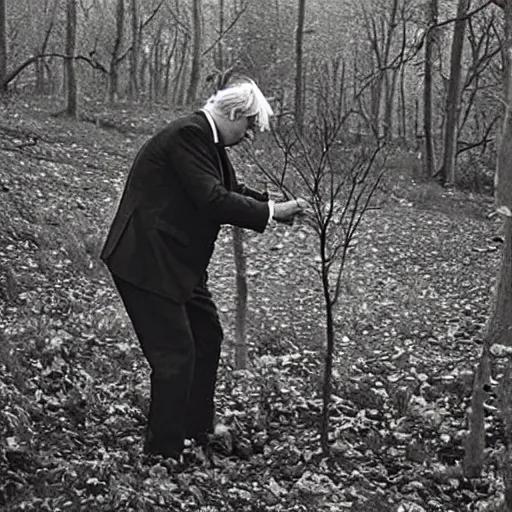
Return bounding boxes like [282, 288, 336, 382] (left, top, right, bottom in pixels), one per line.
[185, 276, 223, 441]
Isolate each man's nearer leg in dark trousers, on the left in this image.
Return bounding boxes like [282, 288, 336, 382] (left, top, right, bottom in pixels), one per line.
[114, 276, 194, 457]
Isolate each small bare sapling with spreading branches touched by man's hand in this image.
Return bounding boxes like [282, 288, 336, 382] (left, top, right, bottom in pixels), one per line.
[246, 63, 385, 455]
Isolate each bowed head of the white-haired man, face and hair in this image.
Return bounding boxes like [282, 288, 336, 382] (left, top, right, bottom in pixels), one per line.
[204, 77, 273, 146]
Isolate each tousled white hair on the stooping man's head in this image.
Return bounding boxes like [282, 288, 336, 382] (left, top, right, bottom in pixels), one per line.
[207, 79, 274, 132]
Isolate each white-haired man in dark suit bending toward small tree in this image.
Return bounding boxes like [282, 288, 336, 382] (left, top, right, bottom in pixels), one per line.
[101, 78, 306, 459]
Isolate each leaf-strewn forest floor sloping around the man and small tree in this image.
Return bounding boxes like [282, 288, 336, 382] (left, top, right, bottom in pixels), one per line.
[0, 99, 503, 512]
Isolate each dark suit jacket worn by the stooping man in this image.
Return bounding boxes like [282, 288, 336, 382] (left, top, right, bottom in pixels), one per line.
[101, 112, 269, 303]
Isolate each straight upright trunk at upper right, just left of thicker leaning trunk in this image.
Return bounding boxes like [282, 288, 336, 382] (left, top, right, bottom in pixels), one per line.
[423, 0, 438, 177]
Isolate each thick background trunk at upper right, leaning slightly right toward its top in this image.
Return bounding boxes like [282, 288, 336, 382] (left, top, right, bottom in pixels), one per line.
[442, 0, 470, 185]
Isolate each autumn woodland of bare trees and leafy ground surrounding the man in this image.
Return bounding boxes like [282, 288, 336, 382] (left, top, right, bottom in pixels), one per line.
[0, 0, 512, 512]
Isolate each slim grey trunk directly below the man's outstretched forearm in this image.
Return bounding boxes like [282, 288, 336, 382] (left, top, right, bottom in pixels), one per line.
[233, 227, 247, 370]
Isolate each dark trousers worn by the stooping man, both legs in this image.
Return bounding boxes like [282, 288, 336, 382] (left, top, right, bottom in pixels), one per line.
[113, 276, 223, 457]
